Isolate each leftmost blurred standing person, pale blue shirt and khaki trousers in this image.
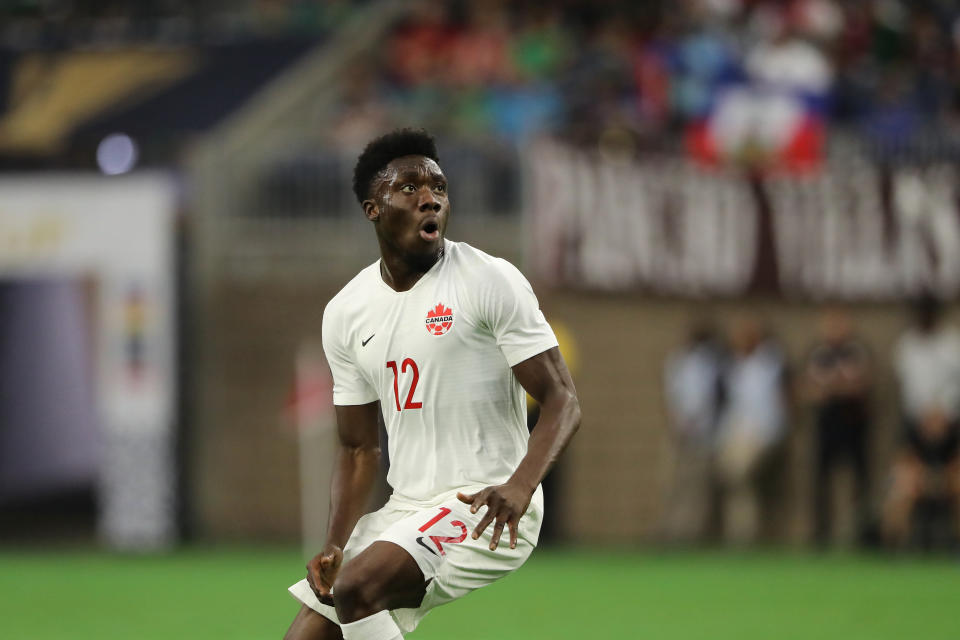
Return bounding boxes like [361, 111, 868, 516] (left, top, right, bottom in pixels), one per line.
[664, 323, 726, 543]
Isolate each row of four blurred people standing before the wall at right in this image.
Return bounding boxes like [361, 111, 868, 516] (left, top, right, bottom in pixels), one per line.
[663, 295, 960, 549]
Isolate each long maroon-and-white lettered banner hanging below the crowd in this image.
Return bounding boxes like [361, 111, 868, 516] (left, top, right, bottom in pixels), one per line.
[525, 142, 960, 299]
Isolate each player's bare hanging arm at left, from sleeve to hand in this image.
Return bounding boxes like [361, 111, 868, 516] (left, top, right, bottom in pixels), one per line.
[307, 402, 380, 606]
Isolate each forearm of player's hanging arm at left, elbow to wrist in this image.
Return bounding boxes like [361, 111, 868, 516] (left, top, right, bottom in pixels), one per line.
[327, 446, 380, 548]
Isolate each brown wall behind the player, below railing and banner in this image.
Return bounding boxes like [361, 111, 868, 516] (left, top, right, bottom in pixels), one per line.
[189, 278, 924, 543]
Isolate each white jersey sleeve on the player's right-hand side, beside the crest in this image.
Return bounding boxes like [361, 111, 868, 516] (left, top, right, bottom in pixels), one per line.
[480, 260, 557, 367]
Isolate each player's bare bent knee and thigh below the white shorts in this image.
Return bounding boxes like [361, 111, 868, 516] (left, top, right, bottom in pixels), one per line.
[333, 540, 426, 621]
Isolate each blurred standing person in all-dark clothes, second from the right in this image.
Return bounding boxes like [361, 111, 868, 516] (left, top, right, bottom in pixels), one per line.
[804, 309, 873, 545]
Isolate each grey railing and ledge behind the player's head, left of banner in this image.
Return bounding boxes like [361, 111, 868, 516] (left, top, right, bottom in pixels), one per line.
[188, 142, 522, 280]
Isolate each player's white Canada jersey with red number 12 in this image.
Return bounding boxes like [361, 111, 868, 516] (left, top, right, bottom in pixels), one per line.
[323, 240, 557, 504]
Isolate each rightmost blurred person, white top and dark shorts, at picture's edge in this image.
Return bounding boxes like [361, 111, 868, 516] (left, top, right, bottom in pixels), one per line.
[883, 295, 960, 546]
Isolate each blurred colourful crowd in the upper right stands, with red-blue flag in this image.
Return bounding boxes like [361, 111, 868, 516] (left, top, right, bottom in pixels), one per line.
[341, 0, 960, 167]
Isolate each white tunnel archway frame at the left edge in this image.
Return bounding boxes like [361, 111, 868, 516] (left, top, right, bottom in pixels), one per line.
[0, 174, 176, 547]
